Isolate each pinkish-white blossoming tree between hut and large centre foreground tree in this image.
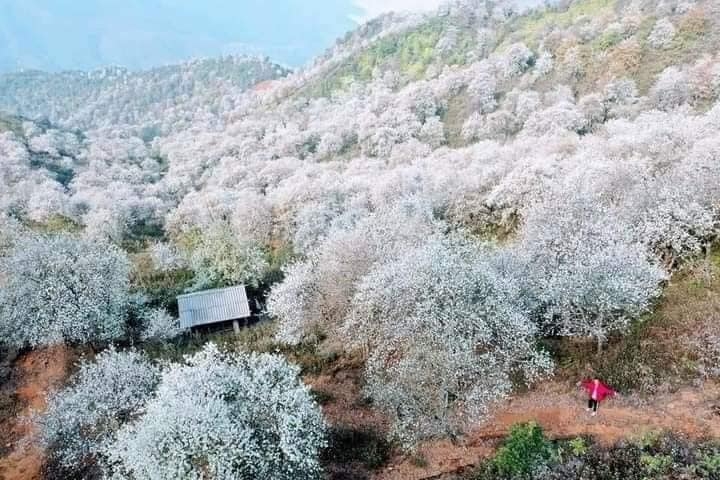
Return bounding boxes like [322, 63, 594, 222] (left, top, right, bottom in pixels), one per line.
[268, 198, 441, 344]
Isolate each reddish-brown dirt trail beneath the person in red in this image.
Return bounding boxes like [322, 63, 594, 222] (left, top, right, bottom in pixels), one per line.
[375, 383, 720, 480]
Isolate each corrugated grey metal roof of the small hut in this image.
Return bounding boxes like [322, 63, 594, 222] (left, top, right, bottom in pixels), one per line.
[178, 285, 250, 328]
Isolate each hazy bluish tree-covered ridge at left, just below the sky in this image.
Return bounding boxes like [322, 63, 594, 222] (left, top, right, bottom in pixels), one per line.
[0, 57, 289, 135]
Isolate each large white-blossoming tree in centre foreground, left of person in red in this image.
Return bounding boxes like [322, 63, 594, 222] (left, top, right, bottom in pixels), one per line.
[344, 236, 551, 448]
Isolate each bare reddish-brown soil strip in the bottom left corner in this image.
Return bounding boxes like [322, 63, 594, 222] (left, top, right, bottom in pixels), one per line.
[0, 347, 72, 480]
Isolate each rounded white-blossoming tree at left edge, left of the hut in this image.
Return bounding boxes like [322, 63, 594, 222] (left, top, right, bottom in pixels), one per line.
[0, 234, 130, 346]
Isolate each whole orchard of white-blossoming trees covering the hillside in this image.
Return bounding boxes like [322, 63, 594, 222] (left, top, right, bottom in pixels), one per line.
[0, 0, 720, 480]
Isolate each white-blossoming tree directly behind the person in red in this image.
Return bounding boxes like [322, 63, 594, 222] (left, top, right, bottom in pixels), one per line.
[517, 194, 666, 352]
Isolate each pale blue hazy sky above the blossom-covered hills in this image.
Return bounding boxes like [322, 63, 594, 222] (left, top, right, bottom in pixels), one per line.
[0, 0, 540, 71]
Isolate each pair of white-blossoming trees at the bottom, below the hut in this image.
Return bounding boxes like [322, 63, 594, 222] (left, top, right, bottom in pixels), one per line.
[37, 344, 326, 480]
